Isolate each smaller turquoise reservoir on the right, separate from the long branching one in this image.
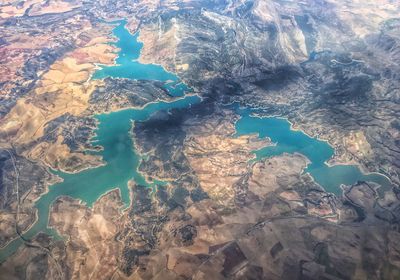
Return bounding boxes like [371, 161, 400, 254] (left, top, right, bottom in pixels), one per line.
[236, 108, 392, 195]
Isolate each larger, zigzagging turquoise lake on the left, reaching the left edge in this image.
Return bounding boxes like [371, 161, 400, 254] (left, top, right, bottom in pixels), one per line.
[0, 21, 201, 262]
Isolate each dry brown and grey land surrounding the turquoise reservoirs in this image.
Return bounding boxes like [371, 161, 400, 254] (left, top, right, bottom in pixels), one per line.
[0, 0, 400, 280]
